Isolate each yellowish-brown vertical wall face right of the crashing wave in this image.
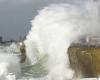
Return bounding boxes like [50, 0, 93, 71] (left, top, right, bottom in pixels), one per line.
[68, 44, 100, 78]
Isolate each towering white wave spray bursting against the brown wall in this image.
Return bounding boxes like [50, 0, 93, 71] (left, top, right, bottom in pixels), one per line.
[25, 2, 100, 80]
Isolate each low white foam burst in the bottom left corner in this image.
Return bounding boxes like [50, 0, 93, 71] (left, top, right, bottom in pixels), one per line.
[0, 53, 21, 80]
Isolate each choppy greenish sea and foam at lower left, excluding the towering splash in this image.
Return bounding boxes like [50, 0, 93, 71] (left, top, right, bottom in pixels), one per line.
[0, 43, 48, 80]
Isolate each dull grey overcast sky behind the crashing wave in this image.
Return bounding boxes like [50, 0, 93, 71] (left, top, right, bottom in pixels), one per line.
[0, 0, 89, 40]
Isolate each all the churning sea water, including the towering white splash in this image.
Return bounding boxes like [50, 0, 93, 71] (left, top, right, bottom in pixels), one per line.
[0, 0, 100, 80]
